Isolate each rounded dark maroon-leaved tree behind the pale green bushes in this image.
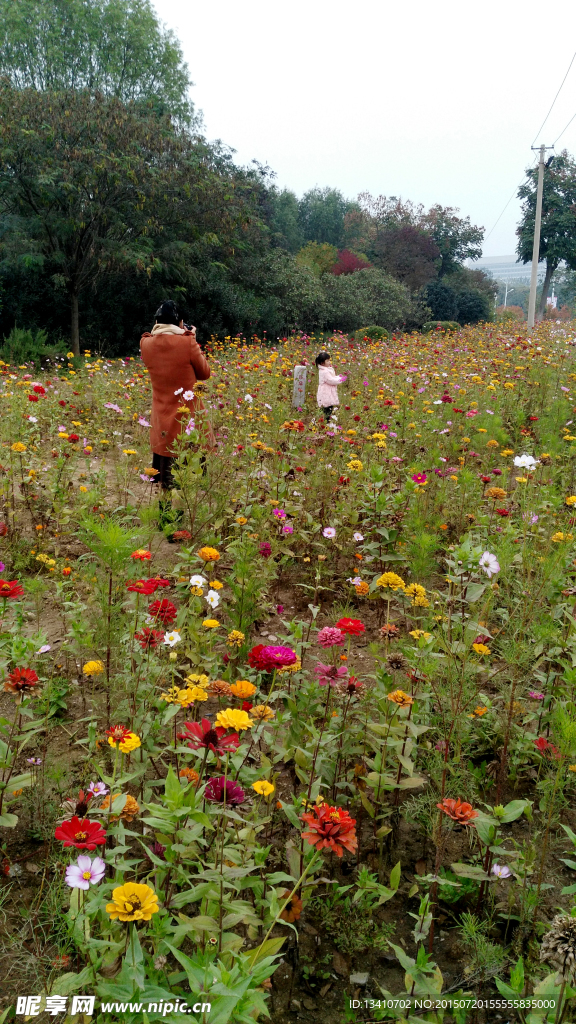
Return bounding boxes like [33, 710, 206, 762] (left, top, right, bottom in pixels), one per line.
[370, 224, 440, 290]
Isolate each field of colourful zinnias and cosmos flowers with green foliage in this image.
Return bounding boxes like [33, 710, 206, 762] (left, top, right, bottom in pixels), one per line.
[0, 322, 576, 1024]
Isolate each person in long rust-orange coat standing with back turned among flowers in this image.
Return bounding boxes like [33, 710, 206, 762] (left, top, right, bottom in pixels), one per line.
[140, 299, 215, 489]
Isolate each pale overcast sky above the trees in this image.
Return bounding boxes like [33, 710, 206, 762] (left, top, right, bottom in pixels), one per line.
[155, 0, 576, 256]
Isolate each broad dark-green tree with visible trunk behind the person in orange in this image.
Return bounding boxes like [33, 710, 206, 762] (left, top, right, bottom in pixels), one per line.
[0, 86, 238, 353]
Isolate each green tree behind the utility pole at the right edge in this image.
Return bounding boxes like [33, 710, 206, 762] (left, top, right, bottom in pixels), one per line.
[517, 150, 576, 316]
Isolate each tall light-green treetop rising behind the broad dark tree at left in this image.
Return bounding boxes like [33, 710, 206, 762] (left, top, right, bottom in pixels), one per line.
[0, 0, 193, 122]
